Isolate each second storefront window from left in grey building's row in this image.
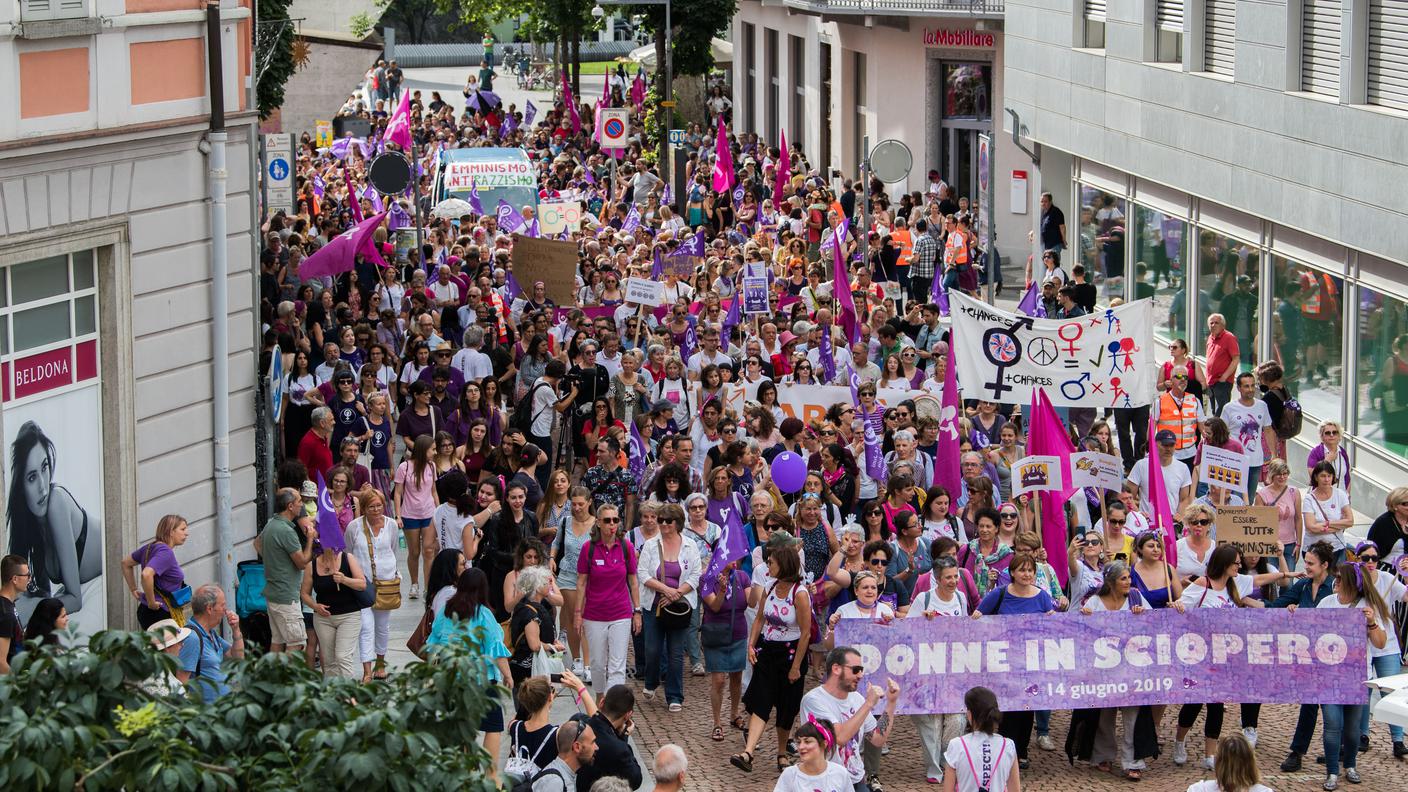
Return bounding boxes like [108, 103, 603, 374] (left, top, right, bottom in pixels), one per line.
[1133, 206, 1188, 340]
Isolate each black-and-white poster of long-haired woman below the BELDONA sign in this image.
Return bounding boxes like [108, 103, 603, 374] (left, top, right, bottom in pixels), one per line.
[0, 385, 107, 634]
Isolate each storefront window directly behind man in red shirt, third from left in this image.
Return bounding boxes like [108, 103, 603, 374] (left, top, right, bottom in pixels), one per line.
[1190, 228, 1262, 371]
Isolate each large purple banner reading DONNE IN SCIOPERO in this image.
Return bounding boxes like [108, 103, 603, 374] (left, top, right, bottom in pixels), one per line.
[836, 607, 1369, 714]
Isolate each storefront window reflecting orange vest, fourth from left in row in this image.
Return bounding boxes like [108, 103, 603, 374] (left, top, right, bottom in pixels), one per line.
[1271, 256, 1345, 419]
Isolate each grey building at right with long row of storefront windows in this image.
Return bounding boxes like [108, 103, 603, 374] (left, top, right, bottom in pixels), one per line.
[1005, 0, 1408, 501]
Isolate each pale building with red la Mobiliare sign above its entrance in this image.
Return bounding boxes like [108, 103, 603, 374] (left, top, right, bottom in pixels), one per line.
[732, 0, 1031, 260]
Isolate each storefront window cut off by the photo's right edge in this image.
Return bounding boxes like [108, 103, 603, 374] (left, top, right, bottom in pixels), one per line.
[1350, 286, 1408, 458]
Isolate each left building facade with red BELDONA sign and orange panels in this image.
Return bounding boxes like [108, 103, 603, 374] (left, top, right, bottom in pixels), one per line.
[0, 0, 258, 631]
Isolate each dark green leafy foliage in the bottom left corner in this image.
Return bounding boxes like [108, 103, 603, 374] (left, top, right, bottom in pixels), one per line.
[0, 631, 501, 792]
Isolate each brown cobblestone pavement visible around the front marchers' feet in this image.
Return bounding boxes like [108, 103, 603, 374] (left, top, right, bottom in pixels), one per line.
[632, 662, 1408, 792]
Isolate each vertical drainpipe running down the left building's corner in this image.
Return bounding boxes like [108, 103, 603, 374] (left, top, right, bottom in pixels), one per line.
[206, 0, 235, 596]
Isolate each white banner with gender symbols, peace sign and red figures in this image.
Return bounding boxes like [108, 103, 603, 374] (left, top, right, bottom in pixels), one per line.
[949, 292, 1156, 407]
